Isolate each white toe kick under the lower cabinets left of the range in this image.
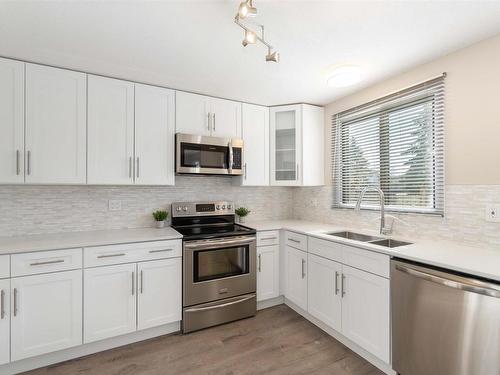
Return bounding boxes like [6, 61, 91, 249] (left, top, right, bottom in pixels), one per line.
[0, 322, 180, 375]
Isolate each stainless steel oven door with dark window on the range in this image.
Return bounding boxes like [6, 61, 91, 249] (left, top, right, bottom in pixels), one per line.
[183, 236, 257, 306]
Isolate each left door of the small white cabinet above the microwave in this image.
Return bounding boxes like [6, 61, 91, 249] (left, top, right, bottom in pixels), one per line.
[175, 91, 212, 136]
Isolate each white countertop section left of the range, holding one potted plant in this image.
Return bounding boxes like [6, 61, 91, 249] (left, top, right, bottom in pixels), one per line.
[0, 227, 182, 255]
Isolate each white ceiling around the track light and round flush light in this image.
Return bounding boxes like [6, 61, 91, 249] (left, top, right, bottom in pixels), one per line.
[0, 0, 500, 105]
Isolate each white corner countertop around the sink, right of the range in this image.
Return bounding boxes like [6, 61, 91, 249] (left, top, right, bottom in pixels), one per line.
[244, 220, 500, 281]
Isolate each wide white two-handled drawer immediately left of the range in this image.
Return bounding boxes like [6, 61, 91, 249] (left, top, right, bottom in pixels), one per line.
[83, 240, 182, 268]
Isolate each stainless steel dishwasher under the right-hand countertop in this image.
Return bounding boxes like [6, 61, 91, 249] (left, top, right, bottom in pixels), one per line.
[391, 259, 500, 375]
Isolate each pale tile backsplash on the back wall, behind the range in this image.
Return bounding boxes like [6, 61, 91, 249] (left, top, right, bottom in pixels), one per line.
[0, 176, 293, 236]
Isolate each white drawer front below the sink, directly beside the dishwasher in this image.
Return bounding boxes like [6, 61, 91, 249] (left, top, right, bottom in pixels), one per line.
[342, 246, 390, 278]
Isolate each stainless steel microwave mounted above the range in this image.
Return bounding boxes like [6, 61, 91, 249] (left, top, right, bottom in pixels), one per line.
[175, 133, 243, 176]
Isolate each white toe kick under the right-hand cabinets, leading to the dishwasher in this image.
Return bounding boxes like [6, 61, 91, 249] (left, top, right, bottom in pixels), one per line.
[285, 298, 397, 375]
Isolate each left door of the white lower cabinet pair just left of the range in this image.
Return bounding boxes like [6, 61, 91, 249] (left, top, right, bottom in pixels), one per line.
[84, 263, 136, 343]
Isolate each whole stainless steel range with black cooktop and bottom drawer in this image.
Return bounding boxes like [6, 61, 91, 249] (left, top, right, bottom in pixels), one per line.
[172, 202, 257, 333]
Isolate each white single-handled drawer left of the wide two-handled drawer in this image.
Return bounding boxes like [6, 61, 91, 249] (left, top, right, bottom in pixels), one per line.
[10, 249, 82, 277]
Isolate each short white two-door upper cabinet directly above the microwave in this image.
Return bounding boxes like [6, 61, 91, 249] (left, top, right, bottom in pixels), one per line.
[176, 91, 241, 138]
